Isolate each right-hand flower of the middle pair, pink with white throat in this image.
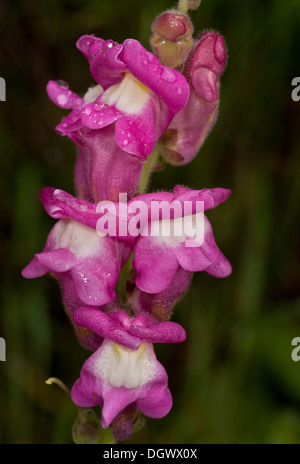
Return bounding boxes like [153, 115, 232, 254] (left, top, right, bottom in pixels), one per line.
[132, 186, 232, 293]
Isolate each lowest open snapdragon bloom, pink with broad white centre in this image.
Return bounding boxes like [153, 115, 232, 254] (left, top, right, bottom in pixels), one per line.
[71, 307, 186, 428]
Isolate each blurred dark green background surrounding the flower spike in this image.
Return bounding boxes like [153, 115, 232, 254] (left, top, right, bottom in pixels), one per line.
[0, 0, 300, 444]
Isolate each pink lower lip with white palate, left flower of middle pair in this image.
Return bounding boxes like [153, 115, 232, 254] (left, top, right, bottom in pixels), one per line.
[22, 189, 131, 306]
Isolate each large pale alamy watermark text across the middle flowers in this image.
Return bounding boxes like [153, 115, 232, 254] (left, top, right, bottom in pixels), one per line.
[96, 193, 205, 247]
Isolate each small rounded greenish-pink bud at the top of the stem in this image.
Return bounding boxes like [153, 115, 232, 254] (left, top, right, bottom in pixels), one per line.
[150, 10, 193, 68]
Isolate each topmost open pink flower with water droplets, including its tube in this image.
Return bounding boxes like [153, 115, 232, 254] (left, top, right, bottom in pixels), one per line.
[47, 36, 189, 202]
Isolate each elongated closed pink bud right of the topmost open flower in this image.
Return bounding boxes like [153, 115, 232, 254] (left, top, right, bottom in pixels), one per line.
[161, 31, 227, 166]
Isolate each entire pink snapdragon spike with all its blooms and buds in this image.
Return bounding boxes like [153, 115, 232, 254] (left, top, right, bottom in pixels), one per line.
[22, 5, 231, 439]
